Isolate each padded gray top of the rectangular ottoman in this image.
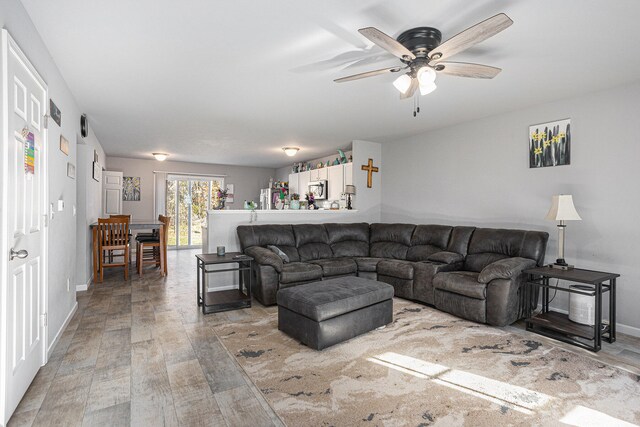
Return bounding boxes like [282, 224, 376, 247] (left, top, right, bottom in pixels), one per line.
[277, 277, 393, 322]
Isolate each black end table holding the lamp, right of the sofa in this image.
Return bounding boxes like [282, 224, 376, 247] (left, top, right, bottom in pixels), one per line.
[524, 267, 620, 352]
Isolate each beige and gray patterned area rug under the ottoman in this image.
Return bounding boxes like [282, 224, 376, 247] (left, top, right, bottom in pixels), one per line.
[214, 299, 640, 426]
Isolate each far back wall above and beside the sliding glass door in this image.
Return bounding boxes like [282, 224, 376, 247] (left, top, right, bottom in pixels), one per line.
[107, 157, 275, 219]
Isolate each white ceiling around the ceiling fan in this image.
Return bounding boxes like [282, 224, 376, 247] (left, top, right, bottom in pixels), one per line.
[22, 0, 640, 167]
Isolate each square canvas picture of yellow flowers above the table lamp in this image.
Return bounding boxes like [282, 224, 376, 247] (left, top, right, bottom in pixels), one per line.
[529, 119, 571, 168]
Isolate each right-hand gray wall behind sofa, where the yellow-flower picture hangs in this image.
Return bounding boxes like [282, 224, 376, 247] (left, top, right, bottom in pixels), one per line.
[382, 83, 640, 335]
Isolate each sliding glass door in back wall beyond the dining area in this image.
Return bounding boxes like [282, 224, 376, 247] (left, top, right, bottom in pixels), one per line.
[166, 176, 224, 248]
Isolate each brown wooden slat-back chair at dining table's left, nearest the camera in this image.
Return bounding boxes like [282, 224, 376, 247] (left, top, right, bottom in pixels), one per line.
[97, 218, 130, 282]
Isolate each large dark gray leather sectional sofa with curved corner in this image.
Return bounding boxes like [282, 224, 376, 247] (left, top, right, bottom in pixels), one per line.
[237, 223, 549, 326]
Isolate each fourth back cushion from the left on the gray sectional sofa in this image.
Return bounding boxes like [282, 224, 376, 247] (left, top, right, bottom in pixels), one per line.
[369, 224, 416, 259]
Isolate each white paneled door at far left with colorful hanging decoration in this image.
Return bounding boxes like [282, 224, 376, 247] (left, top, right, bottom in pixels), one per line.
[0, 30, 47, 424]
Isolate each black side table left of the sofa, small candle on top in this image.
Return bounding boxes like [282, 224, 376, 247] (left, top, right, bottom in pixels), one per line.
[196, 252, 253, 314]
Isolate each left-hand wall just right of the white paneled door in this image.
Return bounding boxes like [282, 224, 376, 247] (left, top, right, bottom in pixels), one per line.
[0, 0, 106, 344]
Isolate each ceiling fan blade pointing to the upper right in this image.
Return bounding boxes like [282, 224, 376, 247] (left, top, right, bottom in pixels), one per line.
[429, 13, 513, 61]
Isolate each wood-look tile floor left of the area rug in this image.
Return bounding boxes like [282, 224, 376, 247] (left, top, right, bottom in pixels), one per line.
[9, 250, 283, 426]
